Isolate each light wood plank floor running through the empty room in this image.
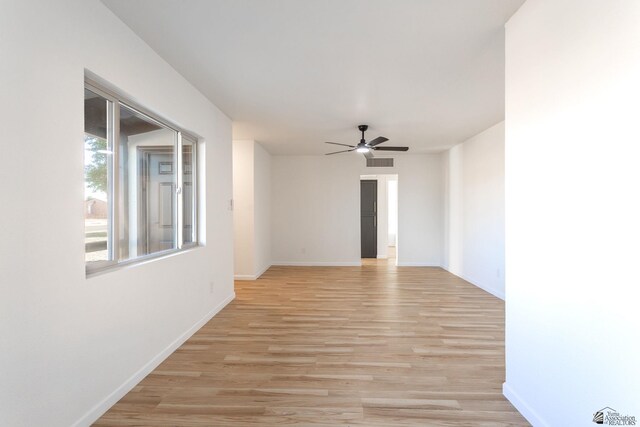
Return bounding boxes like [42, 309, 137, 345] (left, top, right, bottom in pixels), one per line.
[95, 260, 528, 427]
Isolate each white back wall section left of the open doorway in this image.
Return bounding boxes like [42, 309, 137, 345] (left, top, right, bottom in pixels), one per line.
[271, 156, 360, 265]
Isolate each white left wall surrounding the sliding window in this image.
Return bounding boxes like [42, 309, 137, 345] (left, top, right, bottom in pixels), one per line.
[0, 0, 233, 426]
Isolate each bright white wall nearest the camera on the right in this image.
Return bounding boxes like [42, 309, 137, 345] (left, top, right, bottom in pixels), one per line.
[505, 0, 640, 426]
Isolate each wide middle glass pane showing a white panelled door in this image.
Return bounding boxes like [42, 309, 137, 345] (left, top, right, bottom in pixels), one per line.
[118, 104, 177, 260]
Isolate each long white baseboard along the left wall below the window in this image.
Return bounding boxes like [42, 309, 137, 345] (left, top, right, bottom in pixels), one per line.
[73, 292, 236, 427]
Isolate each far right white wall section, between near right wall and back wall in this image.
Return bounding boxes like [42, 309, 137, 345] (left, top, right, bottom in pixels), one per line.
[443, 122, 504, 299]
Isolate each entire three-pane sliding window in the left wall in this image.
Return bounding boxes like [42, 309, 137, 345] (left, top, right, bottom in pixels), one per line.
[84, 81, 197, 272]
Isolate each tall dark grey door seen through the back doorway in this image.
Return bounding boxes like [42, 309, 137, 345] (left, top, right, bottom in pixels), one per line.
[360, 180, 378, 258]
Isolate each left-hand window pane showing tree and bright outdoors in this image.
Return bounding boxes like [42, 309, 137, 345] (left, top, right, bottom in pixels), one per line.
[84, 89, 113, 266]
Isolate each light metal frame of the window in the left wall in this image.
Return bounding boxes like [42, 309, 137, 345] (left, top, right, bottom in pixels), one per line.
[84, 76, 200, 277]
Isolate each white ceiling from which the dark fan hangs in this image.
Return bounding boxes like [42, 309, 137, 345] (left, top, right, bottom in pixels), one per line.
[103, 0, 524, 154]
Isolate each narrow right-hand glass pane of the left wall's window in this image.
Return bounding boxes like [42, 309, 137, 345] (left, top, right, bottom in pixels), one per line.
[182, 135, 196, 243]
